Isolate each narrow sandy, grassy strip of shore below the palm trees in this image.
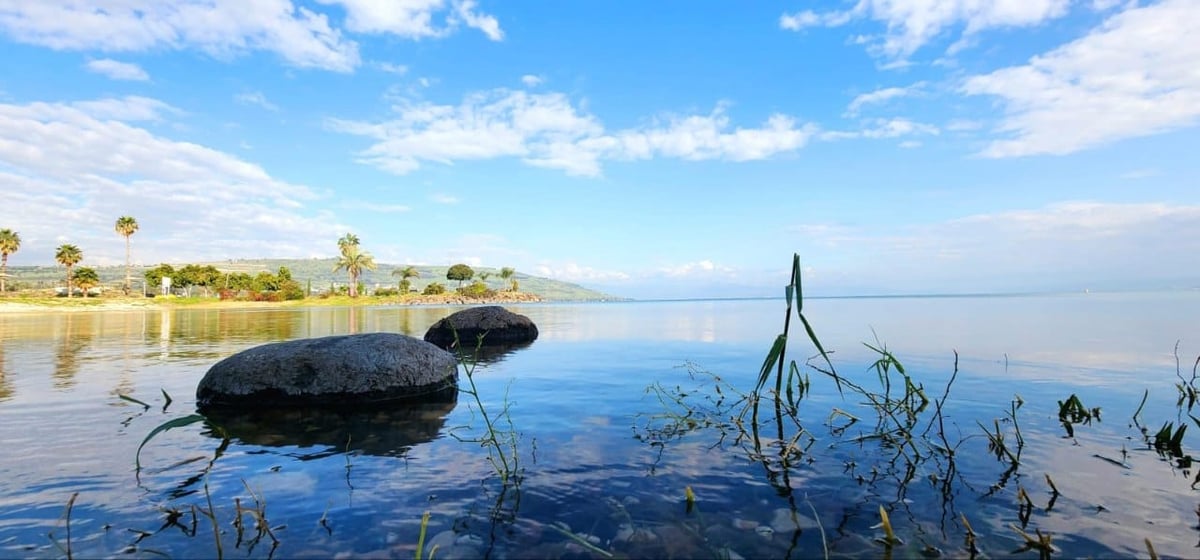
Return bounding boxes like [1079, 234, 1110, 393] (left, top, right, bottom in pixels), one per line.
[0, 291, 545, 314]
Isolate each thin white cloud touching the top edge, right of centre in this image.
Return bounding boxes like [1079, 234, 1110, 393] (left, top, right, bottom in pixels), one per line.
[779, 0, 1070, 61]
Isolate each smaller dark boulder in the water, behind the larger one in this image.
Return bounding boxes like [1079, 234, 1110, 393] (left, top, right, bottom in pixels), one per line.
[425, 306, 538, 349]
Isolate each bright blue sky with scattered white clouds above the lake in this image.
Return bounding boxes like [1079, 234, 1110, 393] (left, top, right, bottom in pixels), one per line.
[0, 0, 1200, 297]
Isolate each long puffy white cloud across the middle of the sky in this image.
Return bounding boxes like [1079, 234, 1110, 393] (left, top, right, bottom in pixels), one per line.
[329, 89, 816, 176]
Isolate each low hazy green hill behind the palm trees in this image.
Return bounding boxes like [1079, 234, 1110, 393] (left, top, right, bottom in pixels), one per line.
[7, 258, 625, 301]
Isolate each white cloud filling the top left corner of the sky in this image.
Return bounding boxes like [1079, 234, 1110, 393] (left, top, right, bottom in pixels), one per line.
[0, 0, 359, 72]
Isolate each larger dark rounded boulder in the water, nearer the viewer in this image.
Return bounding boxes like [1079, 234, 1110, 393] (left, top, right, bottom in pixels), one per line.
[196, 332, 458, 409]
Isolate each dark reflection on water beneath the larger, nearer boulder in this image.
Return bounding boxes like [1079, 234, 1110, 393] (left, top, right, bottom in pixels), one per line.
[205, 401, 456, 460]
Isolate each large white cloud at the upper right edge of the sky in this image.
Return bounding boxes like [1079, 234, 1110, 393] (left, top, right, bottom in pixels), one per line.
[962, 0, 1200, 157]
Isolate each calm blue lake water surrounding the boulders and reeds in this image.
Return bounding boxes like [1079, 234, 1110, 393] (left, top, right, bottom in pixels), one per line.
[0, 293, 1200, 558]
